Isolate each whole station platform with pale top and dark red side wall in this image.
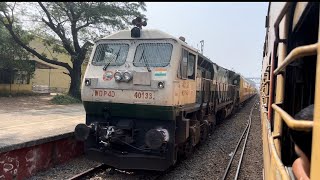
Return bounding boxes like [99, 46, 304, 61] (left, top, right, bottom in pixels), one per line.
[0, 97, 85, 180]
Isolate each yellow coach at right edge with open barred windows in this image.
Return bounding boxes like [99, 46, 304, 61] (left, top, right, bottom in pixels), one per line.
[260, 2, 320, 179]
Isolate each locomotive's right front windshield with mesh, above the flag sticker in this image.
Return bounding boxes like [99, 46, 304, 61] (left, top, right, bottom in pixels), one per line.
[133, 43, 173, 67]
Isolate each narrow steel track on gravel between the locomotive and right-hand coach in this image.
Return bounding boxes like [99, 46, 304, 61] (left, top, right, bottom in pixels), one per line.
[222, 100, 257, 180]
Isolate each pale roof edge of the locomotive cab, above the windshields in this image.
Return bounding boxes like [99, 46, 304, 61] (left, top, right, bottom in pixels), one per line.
[102, 29, 199, 52]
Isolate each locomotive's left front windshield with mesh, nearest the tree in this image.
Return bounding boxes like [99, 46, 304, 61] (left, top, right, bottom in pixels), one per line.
[92, 43, 129, 66]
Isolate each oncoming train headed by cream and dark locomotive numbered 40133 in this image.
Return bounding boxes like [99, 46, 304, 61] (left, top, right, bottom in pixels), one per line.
[75, 19, 253, 171]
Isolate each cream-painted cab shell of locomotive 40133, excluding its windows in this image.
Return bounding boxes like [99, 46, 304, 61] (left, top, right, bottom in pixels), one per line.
[81, 30, 197, 106]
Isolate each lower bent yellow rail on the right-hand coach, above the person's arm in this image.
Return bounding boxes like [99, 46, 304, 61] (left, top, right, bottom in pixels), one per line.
[272, 104, 313, 131]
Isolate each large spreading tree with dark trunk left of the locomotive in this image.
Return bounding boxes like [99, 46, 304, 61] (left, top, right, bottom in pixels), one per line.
[0, 2, 146, 98]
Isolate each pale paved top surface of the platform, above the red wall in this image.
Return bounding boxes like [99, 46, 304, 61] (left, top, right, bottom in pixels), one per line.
[0, 97, 85, 153]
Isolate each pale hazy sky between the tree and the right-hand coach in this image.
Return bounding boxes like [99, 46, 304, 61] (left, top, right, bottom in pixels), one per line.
[144, 2, 268, 77]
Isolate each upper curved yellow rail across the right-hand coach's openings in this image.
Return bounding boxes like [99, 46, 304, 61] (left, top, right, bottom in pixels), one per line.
[273, 43, 318, 75]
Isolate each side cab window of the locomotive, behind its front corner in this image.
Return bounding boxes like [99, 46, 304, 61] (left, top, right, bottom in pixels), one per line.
[179, 49, 196, 79]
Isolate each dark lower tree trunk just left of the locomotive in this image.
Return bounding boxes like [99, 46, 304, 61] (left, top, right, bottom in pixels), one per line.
[68, 60, 81, 99]
